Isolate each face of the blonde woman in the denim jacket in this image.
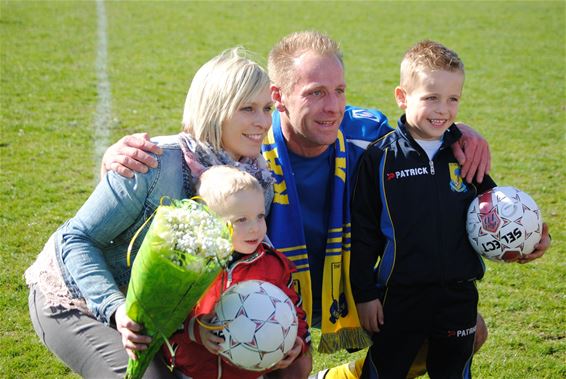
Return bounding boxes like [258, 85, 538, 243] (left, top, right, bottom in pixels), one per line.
[222, 87, 273, 160]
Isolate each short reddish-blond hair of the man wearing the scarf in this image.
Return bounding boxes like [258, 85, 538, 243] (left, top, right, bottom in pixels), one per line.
[267, 31, 344, 91]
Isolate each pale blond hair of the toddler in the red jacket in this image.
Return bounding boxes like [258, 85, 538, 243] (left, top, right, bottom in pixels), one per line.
[197, 165, 264, 215]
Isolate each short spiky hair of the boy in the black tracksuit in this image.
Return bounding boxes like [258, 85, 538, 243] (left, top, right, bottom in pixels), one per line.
[400, 40, 464, 90]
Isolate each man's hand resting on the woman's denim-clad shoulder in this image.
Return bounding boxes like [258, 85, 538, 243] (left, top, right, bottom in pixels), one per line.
[100, 133, 162, 178]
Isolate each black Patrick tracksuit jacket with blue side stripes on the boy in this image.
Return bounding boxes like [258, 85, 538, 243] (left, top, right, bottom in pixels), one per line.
[350, 116, 495, 303]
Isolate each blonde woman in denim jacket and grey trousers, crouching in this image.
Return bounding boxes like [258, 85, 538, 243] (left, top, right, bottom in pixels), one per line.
[26, 48, 286, 378]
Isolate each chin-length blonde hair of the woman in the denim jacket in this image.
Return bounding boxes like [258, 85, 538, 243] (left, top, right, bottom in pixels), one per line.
[183, 47, 270, 149]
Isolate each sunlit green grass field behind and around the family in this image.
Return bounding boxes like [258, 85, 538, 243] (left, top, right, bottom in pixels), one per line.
[0, 0, 566, 379]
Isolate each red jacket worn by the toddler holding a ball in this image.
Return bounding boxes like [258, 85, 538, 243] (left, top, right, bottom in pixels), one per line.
[163, 244, 310, 379]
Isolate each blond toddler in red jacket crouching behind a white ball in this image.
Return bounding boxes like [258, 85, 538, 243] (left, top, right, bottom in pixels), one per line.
[163, 166, 312, 379]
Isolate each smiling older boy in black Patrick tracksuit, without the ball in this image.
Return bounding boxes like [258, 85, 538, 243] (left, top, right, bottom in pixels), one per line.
[350, 41, 495, 379]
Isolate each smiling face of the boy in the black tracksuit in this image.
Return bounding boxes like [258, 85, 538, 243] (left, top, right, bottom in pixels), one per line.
[395, 70, 464, 140]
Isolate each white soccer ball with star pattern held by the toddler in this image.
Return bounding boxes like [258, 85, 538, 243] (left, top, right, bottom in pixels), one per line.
[214, 280, 298, 371]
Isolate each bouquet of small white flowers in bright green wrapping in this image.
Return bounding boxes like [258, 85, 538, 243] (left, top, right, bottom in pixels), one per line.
[126, 200, 232, 379]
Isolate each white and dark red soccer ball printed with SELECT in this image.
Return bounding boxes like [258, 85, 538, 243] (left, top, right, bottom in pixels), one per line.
[466, 187, 542, 262]
